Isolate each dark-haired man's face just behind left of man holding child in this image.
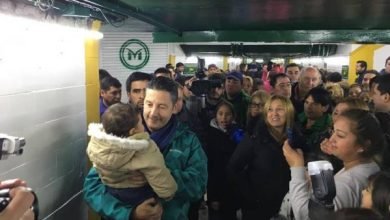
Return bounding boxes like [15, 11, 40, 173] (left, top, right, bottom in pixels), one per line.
[126, 72, 152, 109]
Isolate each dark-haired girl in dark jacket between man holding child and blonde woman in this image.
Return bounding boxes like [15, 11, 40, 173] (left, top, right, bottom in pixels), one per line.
[205, 101, 243, 220]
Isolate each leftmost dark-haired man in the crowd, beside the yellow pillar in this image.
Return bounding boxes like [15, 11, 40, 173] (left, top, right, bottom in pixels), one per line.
[99, 76, 122, 117]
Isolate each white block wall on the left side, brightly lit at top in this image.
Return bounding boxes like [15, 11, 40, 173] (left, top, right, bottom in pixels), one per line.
[0, 14, 87, 220]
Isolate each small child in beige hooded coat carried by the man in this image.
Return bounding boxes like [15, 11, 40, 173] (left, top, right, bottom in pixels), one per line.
[87, 103, 177, 206]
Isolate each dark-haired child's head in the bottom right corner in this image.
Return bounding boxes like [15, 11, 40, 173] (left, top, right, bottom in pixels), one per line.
[362, 172, 390, 219]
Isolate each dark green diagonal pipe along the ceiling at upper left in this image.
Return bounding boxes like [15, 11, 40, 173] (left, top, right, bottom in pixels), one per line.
[68, 0, 182, 36]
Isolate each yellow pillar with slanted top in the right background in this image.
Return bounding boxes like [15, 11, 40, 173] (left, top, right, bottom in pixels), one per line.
[348, 44, 383, 84]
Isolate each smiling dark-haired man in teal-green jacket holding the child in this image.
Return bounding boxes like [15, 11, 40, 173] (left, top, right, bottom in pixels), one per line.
[84, 77, 207, 220]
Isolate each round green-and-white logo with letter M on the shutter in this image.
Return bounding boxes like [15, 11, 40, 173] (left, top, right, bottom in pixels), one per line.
[119, 39, 150, 70]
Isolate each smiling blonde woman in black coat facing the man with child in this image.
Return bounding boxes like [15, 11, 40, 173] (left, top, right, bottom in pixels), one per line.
[228, 95, 294, 220]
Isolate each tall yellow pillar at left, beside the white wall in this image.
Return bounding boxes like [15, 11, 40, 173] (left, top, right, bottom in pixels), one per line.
[85, 21, 101, 220]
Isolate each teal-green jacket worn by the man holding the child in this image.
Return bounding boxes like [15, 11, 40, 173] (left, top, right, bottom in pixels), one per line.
[84, 122, 207, 220]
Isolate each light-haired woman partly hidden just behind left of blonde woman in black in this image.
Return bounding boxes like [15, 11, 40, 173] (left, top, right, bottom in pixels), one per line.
[246, 90, 270, 134]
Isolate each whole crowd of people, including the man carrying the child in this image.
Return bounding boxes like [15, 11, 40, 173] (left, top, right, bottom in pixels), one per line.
[84, 57, 390, 220]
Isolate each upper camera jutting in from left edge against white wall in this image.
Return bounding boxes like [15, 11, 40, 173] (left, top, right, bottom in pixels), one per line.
[0, 133, 26, 160]
